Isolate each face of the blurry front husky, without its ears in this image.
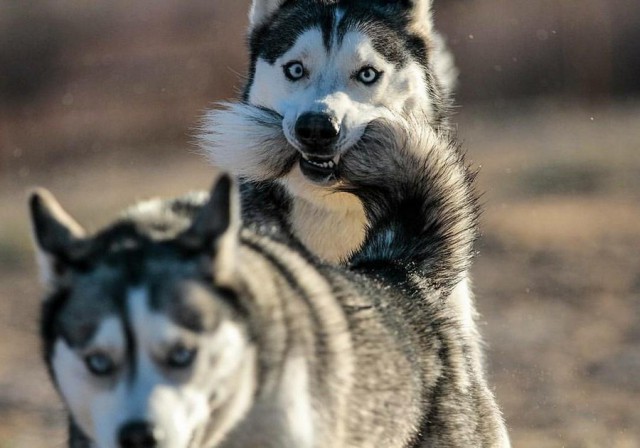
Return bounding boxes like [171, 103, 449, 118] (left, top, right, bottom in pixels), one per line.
[51, 280, 253, 448]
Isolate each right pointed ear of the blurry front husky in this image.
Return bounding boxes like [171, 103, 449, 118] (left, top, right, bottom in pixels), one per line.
[179, 174, 240, 286]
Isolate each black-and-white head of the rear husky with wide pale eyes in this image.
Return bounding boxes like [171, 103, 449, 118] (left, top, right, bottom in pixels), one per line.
[242, 0, 452, 184]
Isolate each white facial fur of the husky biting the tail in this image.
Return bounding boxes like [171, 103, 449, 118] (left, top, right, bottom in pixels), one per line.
[249, 29, 433, 151]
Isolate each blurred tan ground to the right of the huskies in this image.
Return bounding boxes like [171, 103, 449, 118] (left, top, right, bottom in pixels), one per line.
[463, 102, 640, 447]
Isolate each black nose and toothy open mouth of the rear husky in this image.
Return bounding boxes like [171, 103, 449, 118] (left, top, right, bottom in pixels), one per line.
[295, 112, 340, 185]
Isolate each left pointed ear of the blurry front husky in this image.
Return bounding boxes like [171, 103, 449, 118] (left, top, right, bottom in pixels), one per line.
[29, 189, 85, 287]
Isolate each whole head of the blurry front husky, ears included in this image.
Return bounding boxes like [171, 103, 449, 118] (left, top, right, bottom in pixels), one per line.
[30, 178, 255, 448]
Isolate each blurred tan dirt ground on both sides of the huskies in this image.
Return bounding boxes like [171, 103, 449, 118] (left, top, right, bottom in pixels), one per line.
[0, 104, 640, 448]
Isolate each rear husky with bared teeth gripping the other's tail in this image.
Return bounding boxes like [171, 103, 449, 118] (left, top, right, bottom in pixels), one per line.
[200, 0, 480, 378]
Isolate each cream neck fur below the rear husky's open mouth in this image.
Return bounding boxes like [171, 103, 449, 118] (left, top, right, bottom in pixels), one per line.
[284, 169, 366, 264]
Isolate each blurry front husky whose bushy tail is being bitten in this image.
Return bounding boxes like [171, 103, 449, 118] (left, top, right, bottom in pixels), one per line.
[30, 125, 509, 448]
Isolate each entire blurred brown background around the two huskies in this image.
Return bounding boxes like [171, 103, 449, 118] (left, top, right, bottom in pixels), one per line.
[0, 0, 640, 448]
